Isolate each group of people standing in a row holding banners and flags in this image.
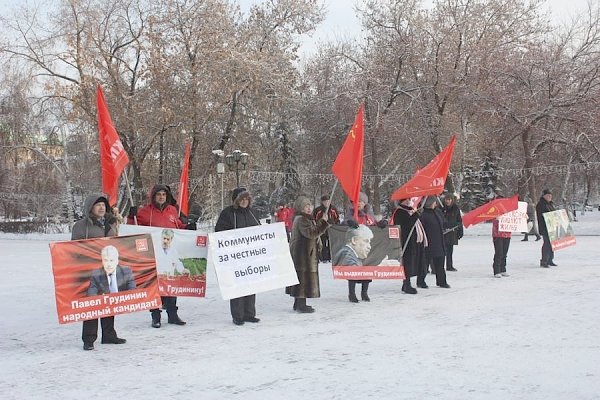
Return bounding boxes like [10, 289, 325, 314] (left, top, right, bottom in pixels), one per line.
[71, 184, 556, 350]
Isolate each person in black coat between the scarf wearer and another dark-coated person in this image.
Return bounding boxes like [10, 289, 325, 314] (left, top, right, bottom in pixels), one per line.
[421, 196, 450, 288]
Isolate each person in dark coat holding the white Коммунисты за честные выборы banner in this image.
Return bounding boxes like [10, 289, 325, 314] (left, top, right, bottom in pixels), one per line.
[215, 187, 260, 325]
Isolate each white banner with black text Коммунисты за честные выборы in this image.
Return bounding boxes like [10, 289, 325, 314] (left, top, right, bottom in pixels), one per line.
[208, 222, 298, 300]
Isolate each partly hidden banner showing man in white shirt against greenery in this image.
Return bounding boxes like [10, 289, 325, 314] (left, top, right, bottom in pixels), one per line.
[119, 225, 208, 297]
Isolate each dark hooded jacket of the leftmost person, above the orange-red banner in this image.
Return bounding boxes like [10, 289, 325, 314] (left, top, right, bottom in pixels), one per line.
[71, 193, 117, 240]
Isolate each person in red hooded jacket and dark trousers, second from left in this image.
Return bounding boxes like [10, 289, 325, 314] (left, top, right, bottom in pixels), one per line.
[128, 184, 186, 328]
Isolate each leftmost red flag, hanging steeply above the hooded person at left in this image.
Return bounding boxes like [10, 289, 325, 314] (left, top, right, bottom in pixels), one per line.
[96, 85, 129, 206]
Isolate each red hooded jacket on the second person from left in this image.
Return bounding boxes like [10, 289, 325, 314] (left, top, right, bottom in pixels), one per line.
[128, 184, 185, 229]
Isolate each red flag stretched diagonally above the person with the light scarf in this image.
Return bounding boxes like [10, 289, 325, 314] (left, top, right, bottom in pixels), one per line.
[392, 135, 456, 200]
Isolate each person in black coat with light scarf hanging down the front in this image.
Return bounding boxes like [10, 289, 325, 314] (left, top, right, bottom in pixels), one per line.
[392, 199, 427, 294]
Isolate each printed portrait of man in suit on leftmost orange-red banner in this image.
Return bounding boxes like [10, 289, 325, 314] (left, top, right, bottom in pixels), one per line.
[87, 246, 135, 296]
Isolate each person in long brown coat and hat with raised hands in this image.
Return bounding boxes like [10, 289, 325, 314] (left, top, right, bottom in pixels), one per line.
[285, 196, 329, 313]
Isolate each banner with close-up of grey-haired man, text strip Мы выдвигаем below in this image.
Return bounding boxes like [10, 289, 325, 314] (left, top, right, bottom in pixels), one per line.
[328, 225, 405, 280]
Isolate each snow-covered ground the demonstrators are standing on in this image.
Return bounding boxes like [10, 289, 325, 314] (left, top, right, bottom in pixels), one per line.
[0, 211, 600, 400]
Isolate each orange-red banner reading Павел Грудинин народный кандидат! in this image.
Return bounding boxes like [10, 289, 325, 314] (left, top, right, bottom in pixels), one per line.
[50, 234, 161, 324]
